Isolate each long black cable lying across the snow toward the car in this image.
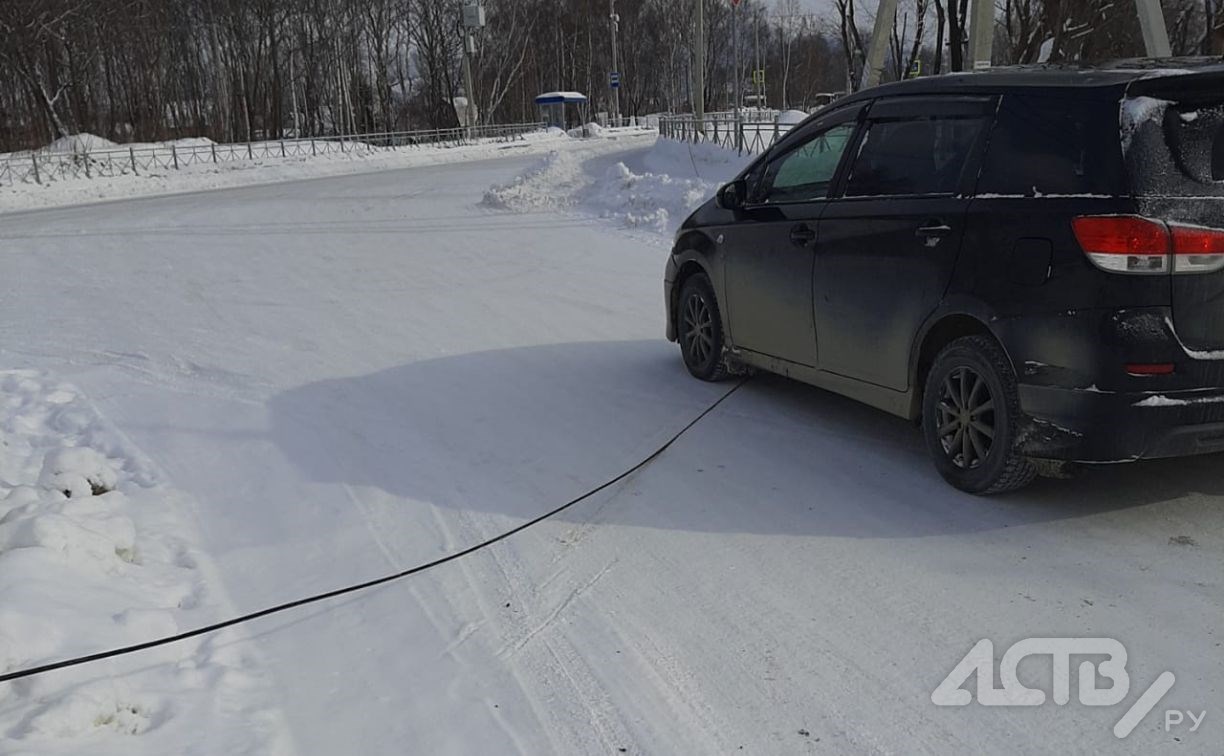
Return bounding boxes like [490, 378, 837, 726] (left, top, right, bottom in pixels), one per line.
[0, 378, 747, 683]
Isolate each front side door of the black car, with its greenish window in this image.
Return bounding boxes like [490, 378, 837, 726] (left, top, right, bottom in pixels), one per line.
[725, 105, 862, 366]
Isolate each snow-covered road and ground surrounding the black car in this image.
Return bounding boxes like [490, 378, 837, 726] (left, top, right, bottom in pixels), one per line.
[0, 139, 1224, 755]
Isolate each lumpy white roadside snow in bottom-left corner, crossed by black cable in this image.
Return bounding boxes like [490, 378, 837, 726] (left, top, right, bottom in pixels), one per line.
[0, 371, 288, 754]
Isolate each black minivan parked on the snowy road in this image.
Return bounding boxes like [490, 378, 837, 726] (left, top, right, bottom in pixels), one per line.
[666, 59, 1224, 494]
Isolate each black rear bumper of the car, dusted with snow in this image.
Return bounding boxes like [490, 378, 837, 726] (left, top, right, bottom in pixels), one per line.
[1020, 384, 1224, 462]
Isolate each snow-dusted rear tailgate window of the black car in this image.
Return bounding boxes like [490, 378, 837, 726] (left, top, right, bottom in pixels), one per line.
[1121, 97, 1224, 197]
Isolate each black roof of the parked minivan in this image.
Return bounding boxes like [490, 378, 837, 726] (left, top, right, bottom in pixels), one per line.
[836, 57, 1224, 105]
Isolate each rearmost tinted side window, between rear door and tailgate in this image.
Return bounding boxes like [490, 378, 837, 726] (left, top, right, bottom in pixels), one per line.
[978, 94, 1126, 197]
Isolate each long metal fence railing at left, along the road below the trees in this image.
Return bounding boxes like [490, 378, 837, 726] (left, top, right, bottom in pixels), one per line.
[0, 122, 547, 186]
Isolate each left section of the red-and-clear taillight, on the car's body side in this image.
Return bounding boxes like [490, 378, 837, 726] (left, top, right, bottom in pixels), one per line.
[1071, 215, 1173, 274]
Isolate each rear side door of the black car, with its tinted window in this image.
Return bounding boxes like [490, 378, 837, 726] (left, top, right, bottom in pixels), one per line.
[813, 97, 995, 390]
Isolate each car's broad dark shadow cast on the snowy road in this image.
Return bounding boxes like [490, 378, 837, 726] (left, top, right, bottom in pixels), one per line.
[271, 341, 1224, 537]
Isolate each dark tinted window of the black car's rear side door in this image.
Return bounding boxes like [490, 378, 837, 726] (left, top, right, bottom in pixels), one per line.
[846, 117, 987, 197]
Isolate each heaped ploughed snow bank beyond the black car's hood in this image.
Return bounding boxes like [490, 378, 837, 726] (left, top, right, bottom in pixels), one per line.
[482, 133, 752, 232]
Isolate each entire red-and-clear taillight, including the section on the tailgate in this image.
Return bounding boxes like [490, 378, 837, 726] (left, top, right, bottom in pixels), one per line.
[1071, 215, 1224, 274]
